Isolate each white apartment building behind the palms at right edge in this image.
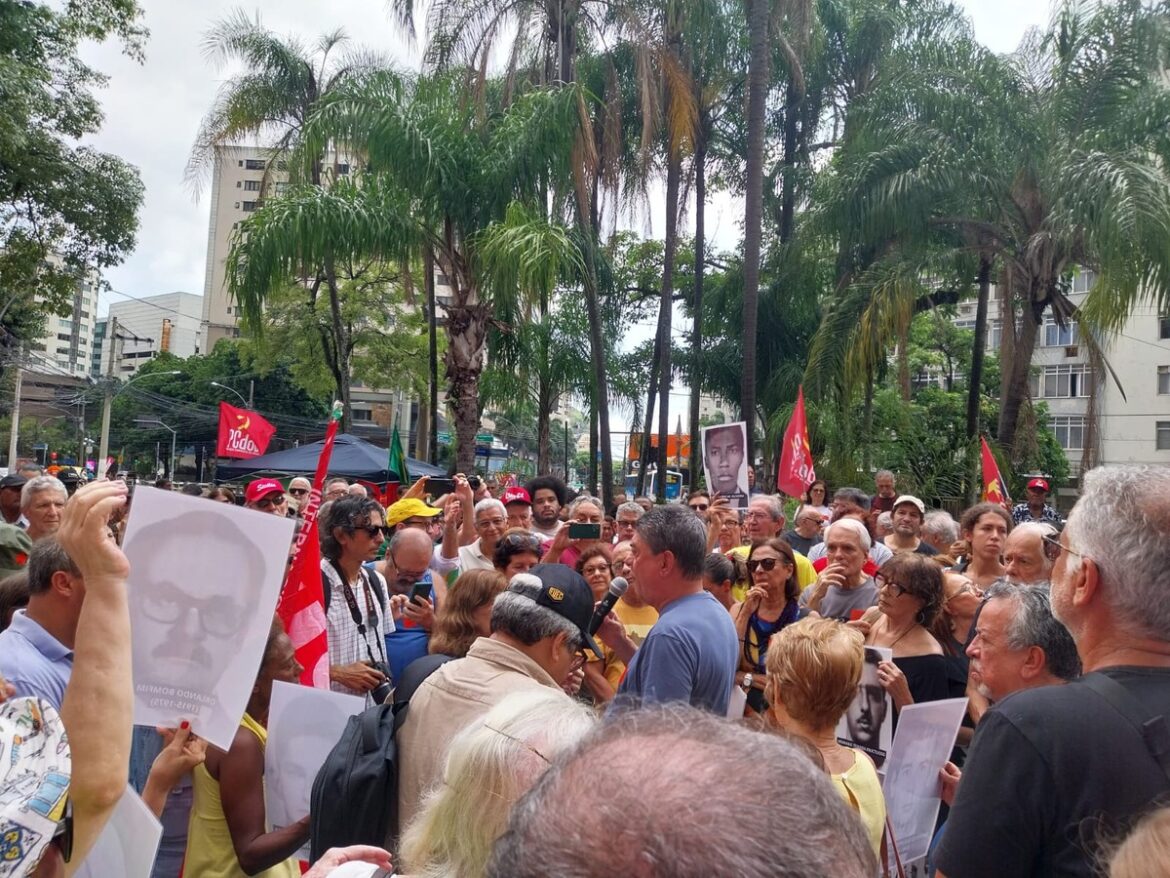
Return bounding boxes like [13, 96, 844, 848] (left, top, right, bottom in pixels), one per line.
[955, 272, 1170, 493]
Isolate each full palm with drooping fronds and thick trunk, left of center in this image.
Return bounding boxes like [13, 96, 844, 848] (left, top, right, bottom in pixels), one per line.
[229, 71, 585, 472]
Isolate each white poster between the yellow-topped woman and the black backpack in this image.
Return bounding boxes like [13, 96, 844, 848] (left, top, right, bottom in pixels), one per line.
[264, 680, 365, 847]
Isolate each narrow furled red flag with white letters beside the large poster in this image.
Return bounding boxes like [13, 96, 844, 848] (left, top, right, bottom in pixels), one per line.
[276, 411, 339, 690]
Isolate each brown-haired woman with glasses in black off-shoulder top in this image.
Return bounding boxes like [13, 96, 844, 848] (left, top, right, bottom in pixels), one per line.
[862, 553, 949, 711]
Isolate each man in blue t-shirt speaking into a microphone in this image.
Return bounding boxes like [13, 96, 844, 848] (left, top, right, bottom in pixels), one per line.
[598, 505, 739, 715]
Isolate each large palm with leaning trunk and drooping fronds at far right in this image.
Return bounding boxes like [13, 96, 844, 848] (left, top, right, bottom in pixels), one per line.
[819, 0, 1170, 460]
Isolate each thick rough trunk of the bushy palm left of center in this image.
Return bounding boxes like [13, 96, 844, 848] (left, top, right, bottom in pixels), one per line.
[447, 302, 489, 473]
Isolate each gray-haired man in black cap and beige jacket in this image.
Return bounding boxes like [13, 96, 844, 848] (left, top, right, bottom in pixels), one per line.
[395, 566, 599, 828]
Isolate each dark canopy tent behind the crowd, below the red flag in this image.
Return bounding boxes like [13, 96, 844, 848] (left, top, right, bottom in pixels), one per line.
[215, 433, 447, 485]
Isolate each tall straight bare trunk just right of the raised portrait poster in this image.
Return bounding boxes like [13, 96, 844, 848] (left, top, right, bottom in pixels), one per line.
[739, 0, 771, 462]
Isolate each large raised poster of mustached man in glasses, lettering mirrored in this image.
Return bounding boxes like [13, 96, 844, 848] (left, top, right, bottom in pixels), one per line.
[123, 487, 296, 749]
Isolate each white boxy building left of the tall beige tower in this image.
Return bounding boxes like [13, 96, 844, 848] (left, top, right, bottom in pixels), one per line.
[101, 293, 204, 378]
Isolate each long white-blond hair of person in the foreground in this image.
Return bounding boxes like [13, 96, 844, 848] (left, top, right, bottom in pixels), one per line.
[395, 687, 597, 878]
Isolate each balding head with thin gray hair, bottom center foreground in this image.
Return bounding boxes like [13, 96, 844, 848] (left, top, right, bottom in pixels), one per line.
[487, 707, 878, 878]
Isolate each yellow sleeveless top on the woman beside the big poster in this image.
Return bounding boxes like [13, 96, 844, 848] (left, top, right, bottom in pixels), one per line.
[183, 714, 301, 878]
